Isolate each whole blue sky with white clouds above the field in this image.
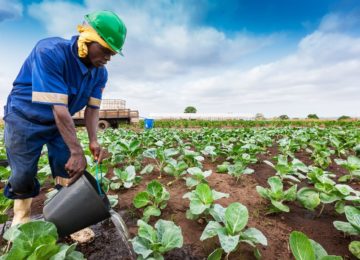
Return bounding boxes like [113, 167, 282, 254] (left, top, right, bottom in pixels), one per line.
[0, 0, 360, 117]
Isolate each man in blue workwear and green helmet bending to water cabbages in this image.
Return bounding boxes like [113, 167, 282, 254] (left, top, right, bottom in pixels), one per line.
[4, 11, 126, 228]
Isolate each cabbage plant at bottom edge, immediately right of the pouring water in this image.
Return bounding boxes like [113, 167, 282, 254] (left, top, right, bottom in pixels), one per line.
[130, 219, 183, 260]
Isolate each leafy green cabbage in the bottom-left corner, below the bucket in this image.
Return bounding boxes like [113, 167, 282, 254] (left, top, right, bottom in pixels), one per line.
[0, 221, 85, 260]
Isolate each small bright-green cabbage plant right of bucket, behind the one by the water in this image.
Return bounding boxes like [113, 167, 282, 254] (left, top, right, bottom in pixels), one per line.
[133, 181, 170, 222]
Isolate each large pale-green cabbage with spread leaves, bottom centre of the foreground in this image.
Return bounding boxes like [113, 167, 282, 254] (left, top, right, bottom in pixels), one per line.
[200, 202, 267, 259]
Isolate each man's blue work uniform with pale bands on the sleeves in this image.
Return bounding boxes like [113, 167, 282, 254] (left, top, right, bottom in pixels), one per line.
[4, 36, 107, 199]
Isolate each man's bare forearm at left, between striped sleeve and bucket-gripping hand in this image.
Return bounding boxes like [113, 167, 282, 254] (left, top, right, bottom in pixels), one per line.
[53, 105, 83, 154]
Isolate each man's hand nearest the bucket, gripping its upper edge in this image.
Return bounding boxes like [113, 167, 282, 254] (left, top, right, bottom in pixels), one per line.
[65, 151, 87, 185]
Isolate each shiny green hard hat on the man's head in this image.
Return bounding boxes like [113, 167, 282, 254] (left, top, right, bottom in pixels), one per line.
[85, 11, 126, 53]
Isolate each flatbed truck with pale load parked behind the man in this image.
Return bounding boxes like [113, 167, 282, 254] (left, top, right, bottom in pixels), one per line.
[73, 99, 139, 129]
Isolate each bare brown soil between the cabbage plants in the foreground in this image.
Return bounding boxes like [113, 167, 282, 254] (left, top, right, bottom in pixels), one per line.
[0, 146, 357, 260]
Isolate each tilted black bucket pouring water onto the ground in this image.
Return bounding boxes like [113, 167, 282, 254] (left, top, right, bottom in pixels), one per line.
[43, 171, 111, 237]
